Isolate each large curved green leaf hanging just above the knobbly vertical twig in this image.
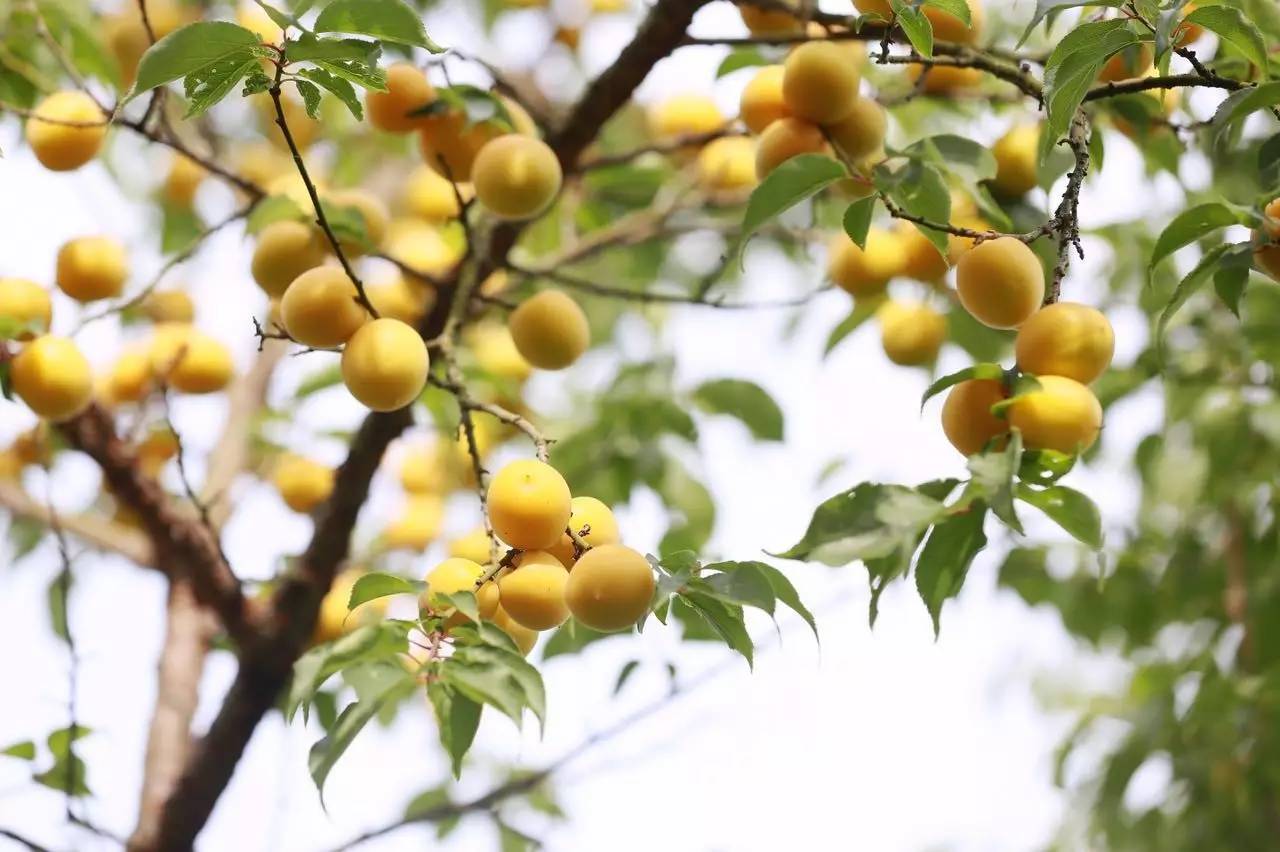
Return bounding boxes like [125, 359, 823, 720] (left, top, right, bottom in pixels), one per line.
[1041, 18, 1140, 160]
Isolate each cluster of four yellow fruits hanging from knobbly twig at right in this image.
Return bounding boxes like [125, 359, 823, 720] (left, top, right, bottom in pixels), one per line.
[942, 237, 1115, 455]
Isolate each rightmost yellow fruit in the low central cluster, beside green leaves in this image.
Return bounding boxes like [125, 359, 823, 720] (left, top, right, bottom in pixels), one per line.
[564, 545, 654, 632]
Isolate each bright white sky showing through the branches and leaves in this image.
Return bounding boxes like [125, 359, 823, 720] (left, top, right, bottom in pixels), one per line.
[0, 3, 1208, 852]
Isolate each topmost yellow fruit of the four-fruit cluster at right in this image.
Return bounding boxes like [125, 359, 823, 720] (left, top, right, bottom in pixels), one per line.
[956, 237, 1044, 329]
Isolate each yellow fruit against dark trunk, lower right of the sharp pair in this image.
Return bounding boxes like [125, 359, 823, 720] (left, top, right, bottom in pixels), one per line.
[342, 317, 430, 411]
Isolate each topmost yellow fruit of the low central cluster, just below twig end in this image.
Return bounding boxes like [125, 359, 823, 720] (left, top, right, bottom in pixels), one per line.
[489, 459, 572, 550]
